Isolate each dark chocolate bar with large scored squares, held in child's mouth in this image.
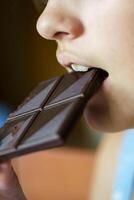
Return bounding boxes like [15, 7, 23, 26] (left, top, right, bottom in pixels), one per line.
[0, 68, 107, 161]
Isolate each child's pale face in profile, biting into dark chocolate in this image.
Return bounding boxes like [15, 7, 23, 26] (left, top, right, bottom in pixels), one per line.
[37, 0, 134, 132]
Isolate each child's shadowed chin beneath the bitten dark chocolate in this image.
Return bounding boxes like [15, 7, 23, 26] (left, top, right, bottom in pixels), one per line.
[84, 78, 132, 133]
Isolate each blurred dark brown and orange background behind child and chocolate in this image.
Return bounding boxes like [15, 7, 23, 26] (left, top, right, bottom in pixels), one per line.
[0, 0, 101, 200]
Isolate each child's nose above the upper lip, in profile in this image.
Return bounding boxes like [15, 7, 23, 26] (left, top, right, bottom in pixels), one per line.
[37, 5, 83, 40]
